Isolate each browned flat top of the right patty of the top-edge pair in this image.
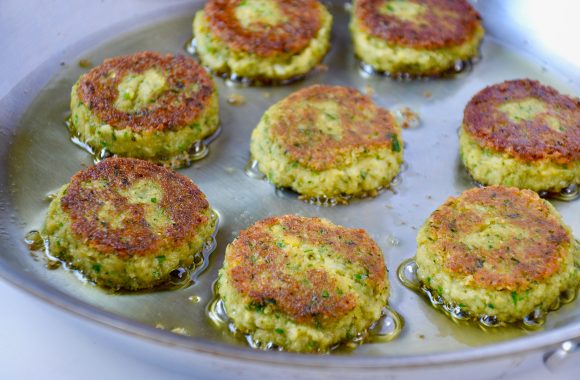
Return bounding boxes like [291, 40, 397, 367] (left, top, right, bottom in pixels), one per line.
[354, 0, 481, 49]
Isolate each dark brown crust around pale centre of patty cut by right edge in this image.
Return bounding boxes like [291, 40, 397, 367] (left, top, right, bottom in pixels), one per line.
[463, 79, 580, 164]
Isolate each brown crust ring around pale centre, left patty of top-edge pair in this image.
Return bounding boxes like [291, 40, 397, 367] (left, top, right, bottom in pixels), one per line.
[204, 0, 321, 57]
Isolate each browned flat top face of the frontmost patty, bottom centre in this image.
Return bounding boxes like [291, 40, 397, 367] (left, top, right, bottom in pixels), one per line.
[225, 215, 386, 323]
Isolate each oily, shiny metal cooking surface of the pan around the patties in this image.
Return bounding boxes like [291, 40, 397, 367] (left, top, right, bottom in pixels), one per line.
[0, 1, 580, 365]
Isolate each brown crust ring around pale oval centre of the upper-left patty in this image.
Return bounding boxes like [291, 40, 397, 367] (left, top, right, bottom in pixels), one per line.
[77, 51, 215, 132]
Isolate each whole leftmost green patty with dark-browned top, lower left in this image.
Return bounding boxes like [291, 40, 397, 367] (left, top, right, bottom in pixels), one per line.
[44, 158, 216, 290]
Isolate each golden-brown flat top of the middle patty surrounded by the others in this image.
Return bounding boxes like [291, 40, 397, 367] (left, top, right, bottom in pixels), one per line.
[269, 85, 402, 170]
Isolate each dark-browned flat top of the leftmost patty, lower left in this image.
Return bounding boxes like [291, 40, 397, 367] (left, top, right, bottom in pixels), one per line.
[61, 158, 209, 257]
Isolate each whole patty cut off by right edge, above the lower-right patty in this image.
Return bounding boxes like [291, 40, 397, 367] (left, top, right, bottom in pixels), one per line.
[459, 79, 580, 192]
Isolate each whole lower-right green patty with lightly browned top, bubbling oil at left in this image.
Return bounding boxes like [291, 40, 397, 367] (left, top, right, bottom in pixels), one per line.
[415, 186, 580, 322]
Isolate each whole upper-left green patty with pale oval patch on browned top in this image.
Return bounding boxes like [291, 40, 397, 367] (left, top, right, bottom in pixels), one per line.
[70, 51, 219, 168]
